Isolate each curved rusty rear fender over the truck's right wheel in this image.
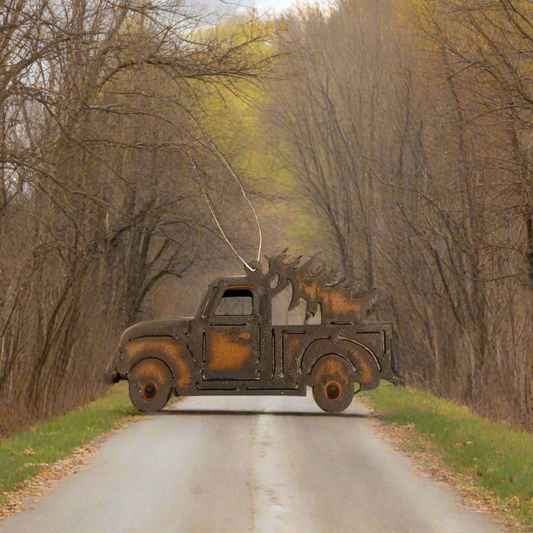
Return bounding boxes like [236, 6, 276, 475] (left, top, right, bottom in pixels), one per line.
[301, 337, 380, 390]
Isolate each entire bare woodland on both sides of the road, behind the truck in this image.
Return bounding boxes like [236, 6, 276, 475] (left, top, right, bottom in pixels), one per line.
[0, 0, 533, 468]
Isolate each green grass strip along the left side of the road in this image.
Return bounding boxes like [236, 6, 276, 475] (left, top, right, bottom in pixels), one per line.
[0, 383, 140, 503]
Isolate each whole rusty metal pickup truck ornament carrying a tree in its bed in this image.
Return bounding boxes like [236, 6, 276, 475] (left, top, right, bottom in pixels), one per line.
[110, 252, 395, 412]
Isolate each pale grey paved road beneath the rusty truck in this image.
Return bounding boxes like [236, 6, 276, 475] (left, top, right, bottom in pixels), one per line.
[0, 395, 508, 533]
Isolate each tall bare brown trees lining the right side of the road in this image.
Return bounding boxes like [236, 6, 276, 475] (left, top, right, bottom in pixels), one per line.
[268, 0, 533, 430]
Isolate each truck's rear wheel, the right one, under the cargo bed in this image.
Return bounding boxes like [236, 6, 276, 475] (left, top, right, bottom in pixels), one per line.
[311, 354, 354, 413]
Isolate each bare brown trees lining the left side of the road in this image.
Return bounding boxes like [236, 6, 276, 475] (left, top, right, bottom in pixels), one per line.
[0, 0, 280, 436]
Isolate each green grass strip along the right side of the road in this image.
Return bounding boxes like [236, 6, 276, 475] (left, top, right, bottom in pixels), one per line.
[364, 382, 533, 525]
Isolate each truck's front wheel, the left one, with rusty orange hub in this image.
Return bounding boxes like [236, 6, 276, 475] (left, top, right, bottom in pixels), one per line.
[128, 359, 172, 413]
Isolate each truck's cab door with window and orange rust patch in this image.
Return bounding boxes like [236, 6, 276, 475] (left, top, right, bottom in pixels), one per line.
[202, 286, 261, 381]
